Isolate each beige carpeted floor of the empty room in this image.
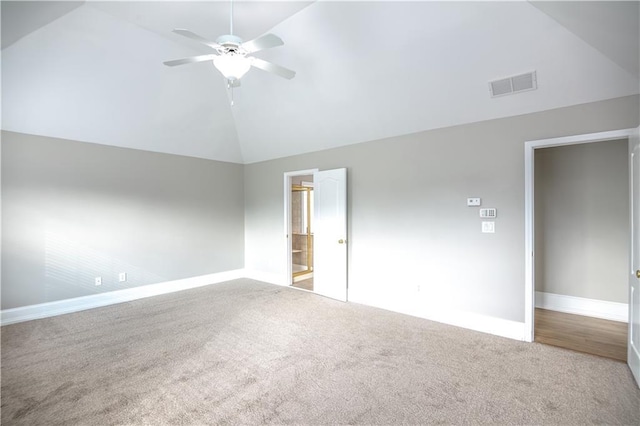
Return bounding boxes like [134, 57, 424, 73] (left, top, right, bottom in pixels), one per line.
[1, 280, 640, 425]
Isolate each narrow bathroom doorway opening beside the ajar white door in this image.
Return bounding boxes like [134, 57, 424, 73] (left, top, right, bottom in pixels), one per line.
[290, 174, 314, 291]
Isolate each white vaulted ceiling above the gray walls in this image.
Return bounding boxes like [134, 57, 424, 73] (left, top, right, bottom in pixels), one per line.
[2, 1, 640, 163]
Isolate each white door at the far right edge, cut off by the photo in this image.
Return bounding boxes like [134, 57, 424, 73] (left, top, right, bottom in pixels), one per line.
[627, 127, 640, 386]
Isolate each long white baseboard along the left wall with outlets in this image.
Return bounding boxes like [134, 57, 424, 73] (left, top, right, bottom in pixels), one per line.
[0, 269, 245, 325]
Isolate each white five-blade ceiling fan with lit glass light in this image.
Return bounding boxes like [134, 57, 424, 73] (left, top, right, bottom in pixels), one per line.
[164, 0, 296, 87]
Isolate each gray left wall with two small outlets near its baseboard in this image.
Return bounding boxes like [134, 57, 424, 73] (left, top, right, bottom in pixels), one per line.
[2, 131, 244, 309]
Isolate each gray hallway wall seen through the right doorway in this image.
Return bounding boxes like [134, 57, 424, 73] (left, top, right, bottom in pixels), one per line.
[535, 139, 629, 303]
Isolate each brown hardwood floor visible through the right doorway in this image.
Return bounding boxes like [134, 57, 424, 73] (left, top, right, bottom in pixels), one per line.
[534, 308, 627, 362]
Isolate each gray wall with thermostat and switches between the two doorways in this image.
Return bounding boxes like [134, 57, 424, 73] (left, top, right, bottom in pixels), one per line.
[245, 96, 639, 321]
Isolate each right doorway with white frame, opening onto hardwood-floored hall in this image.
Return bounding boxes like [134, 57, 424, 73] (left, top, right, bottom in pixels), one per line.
[525, 130, 631, 361]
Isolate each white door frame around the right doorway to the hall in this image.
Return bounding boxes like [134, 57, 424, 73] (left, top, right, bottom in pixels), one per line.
[524, 129, 635, 342]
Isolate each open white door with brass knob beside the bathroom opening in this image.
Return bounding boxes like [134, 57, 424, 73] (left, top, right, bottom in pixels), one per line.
[313, 169, 347, 301]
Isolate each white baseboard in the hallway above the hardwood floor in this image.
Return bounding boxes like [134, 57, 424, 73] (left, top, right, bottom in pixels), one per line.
[536, 291, 629, 322]
